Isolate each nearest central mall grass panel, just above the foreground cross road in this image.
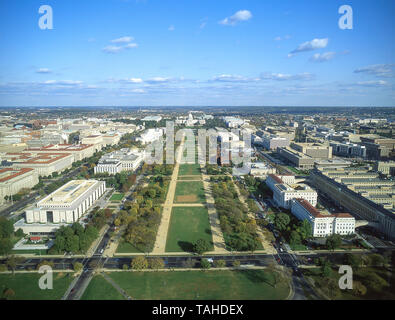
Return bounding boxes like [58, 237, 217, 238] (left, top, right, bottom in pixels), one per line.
[166, 207, 212, 252]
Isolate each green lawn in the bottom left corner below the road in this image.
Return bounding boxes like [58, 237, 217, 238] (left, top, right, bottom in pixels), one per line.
[0, 273, 73, 300]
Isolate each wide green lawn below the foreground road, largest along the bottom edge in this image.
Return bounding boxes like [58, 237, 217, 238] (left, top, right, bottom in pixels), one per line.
[110, 270, 289, 300]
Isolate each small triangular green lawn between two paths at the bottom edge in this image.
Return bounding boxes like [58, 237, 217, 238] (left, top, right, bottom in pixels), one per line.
[81, 275, 124, 300]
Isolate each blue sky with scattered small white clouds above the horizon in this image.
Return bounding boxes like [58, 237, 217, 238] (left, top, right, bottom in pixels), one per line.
[0, 0, 395, 106]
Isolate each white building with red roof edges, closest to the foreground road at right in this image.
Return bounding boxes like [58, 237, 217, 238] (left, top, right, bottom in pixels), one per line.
[291, 199, 355, 237]
